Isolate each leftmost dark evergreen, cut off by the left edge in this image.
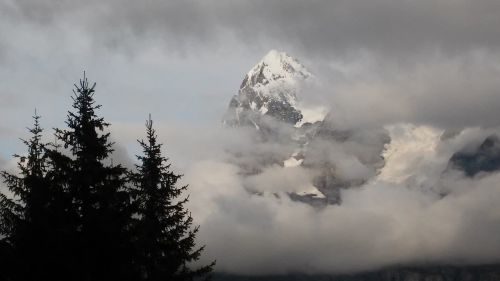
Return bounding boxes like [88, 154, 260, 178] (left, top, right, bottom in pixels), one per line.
[0, 112, 51, 280]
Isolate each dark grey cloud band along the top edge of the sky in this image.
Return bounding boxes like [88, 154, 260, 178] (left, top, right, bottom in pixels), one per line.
[3, 0, 500, 58]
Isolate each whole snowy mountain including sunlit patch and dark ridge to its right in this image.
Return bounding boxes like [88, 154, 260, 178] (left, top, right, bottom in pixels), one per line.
[223, 50, 500, 206]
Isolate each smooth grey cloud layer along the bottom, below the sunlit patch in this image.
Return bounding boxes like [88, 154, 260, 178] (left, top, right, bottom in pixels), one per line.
[189, 158, 500, 274]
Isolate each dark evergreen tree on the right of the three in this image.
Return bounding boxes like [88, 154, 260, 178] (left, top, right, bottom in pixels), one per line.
[131, 117, 214, 281]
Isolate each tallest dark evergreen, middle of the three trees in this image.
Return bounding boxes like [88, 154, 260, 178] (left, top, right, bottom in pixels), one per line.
[49, 76, 137, 280]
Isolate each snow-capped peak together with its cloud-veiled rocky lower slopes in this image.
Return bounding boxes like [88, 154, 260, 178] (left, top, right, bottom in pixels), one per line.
[223, 50, 388, 205]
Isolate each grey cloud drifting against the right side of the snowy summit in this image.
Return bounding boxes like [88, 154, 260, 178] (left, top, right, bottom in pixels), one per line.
[305, 51, 500, 129]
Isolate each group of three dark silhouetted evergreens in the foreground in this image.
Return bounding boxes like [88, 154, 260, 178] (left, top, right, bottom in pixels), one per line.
[0, 76, 214, 281]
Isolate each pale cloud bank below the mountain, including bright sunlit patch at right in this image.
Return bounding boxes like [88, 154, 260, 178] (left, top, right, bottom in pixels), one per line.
[148, 121, 500, 274]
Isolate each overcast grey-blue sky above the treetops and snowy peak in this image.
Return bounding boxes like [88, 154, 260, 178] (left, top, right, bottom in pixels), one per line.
[0, 0, 500, 142]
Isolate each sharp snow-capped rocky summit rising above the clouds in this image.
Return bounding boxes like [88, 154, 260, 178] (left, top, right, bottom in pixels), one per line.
[223, 50, 324, 129]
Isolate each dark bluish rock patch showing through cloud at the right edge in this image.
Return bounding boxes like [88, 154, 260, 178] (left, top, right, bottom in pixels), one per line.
[449, 135, 500, 177]
